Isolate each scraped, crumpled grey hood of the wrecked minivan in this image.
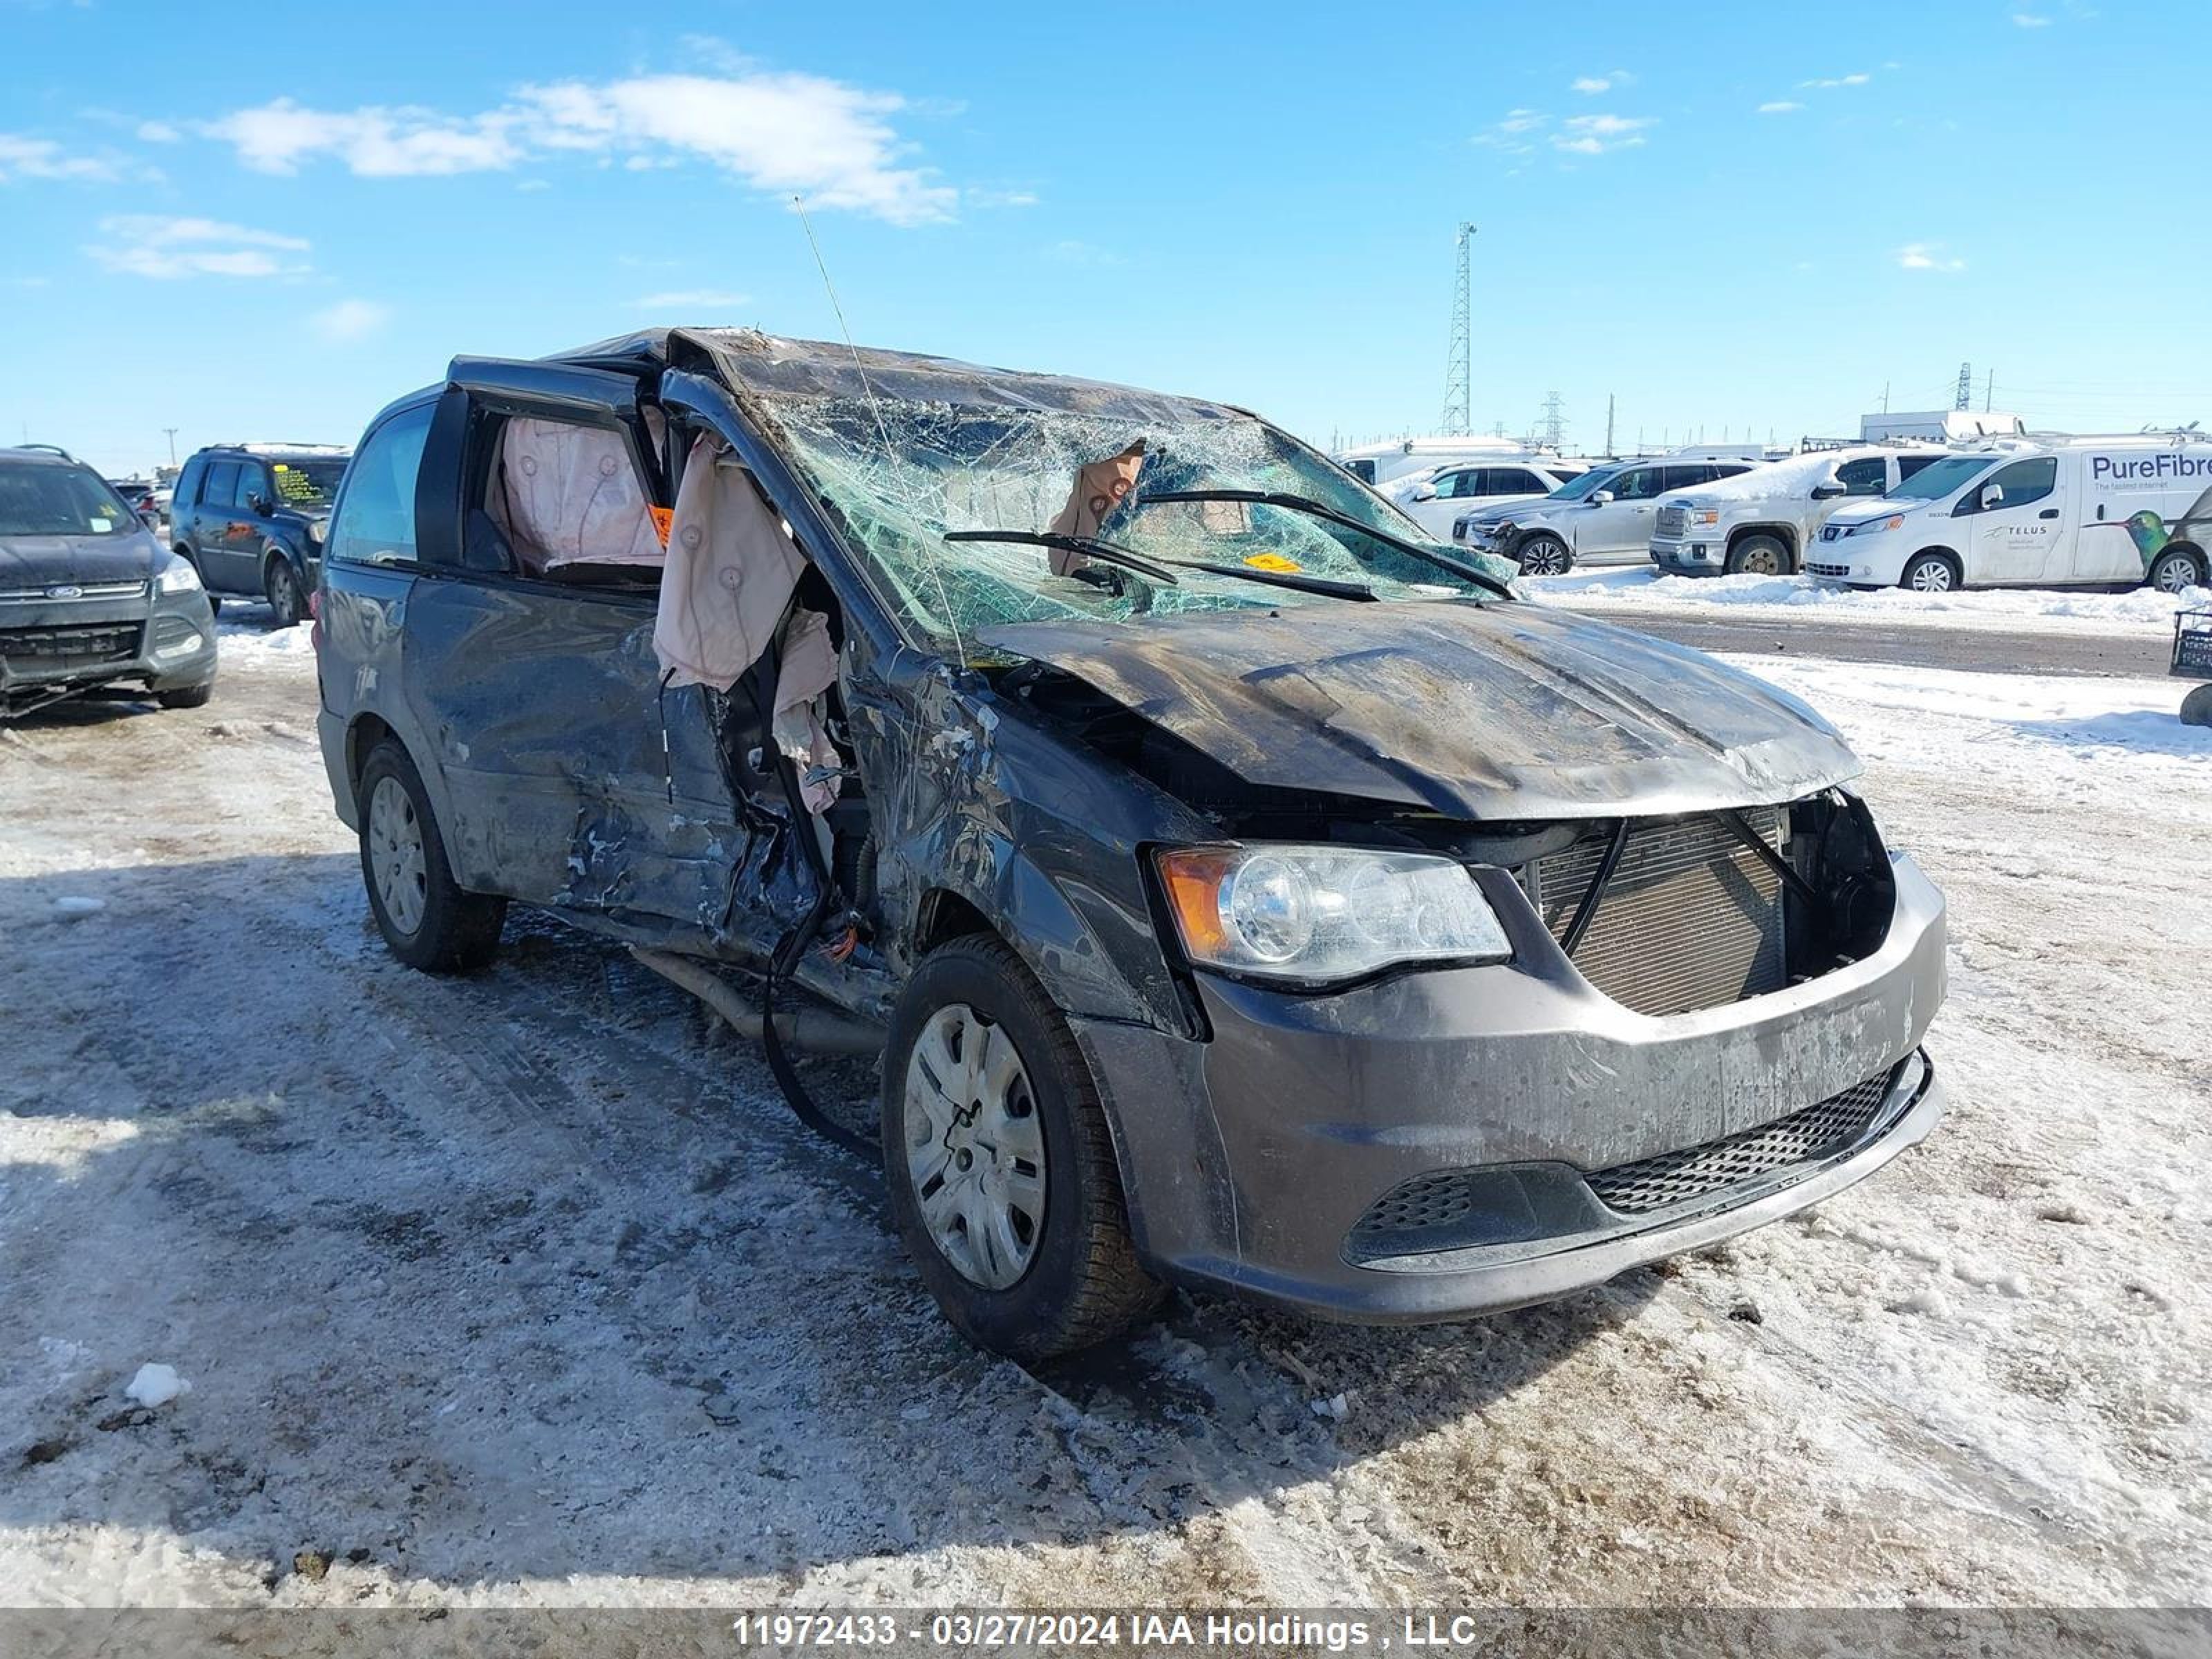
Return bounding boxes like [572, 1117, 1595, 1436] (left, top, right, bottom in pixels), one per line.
[980, 601, 1860, 821]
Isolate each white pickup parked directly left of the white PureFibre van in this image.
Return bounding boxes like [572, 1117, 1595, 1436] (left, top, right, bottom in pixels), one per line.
[1650, 444, 1947, 575]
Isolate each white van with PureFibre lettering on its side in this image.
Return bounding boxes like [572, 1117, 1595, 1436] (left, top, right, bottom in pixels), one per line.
[1805, 438, 2212, 593]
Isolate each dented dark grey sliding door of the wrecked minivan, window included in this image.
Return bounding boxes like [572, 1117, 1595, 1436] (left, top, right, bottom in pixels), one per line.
[405, 361, 743, 936]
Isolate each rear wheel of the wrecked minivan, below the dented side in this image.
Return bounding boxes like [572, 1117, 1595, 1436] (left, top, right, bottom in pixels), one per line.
[354, 741, 507, 973]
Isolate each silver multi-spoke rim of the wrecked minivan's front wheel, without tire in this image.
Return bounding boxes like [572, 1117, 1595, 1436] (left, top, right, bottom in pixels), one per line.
[905, 1002, 1044, 1290]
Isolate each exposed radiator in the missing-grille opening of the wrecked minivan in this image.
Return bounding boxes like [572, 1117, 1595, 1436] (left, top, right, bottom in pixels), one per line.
[1535, 807, 1788, 1015]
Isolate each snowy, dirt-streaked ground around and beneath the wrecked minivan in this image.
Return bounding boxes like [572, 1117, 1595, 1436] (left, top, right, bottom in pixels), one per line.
[0, 624, 2212, 1606]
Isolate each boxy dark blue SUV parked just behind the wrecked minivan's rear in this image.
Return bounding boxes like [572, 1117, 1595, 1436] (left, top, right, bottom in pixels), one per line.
[168, 444, 350, 628]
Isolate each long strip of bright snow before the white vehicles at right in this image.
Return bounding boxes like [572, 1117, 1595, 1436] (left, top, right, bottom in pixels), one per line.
[1519, 564, 2212, 632]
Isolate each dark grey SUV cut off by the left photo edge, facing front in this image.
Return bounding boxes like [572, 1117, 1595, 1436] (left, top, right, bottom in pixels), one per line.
[0, 447, 214, 716]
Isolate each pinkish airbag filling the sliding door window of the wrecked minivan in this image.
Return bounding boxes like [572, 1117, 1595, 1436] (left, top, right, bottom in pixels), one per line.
[491, 416, 664, 571]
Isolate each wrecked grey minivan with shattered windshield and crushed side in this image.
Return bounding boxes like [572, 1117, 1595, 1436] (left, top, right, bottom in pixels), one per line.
[317, 330, 1944, 1358]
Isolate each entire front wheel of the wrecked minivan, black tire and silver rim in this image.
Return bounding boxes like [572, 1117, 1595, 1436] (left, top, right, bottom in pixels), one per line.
[883, 933, 1165, 1360]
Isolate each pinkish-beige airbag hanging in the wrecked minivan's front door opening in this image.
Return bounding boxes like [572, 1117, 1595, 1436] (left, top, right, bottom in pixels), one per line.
[653, 435, 805, 706]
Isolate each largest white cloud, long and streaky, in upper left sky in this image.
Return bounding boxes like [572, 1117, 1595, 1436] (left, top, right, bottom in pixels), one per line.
[199, 59, 968, 225]
